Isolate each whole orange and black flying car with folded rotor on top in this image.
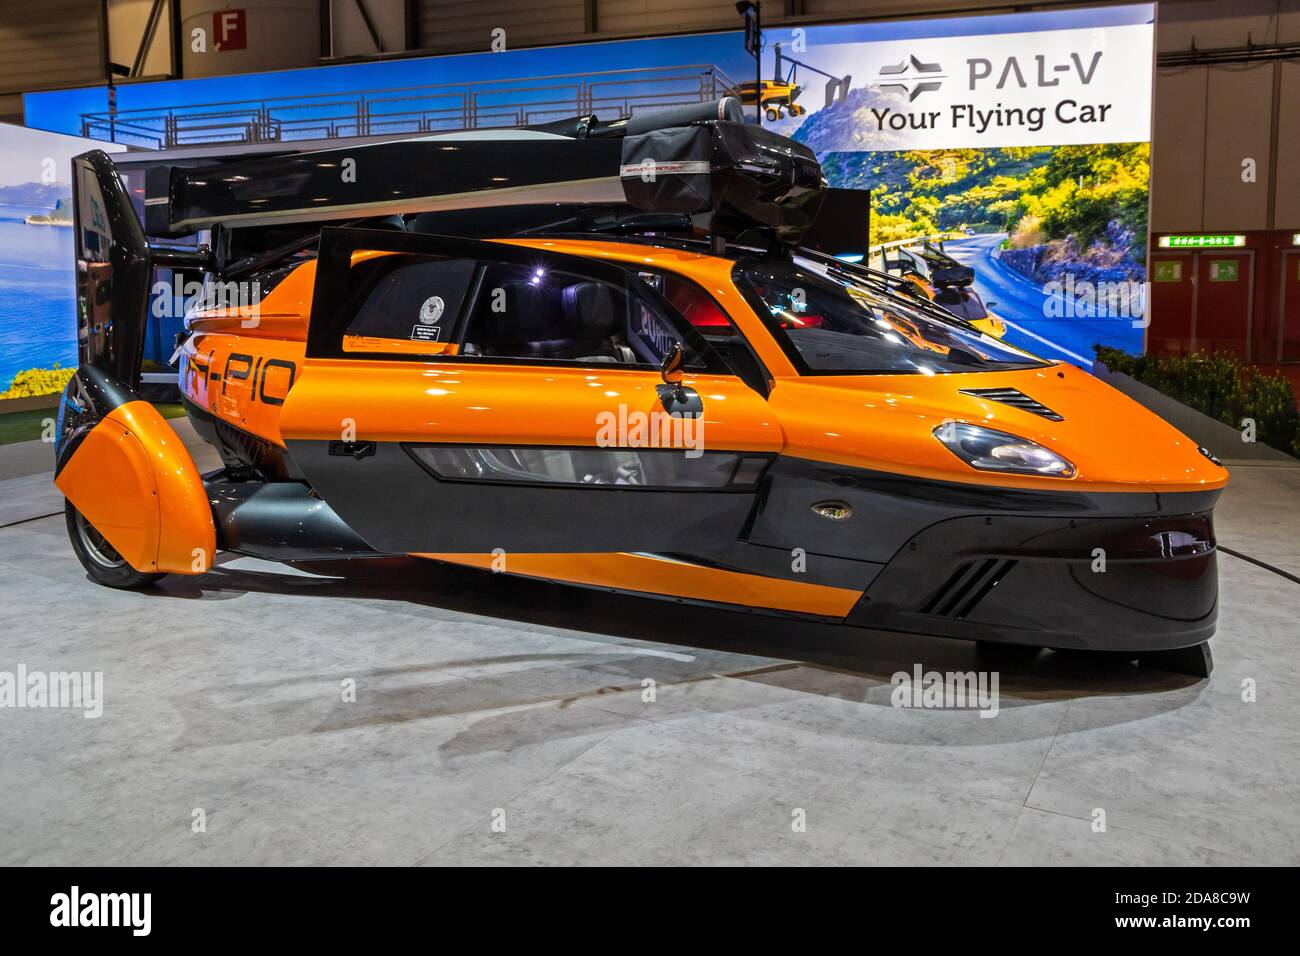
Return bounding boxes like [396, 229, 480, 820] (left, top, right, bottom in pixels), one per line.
[55, 100, 1227, 672]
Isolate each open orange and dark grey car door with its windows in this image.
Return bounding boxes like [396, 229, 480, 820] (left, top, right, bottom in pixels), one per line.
[281, 229, 783, 553]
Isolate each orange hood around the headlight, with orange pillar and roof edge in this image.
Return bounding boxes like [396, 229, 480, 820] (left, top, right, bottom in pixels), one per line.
[493, 239, 1229, 492]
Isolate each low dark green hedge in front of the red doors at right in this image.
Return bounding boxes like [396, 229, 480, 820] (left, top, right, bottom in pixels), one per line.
[1095, 345, 1300, 458]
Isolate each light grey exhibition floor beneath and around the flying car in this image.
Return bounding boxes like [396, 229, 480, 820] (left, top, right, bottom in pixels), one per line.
[0, 423, 1300, 865]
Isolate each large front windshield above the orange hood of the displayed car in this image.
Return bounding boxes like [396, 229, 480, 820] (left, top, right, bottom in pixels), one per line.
[732, 256, 1047, 375]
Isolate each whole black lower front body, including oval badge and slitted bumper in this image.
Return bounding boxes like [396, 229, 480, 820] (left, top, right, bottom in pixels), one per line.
[733, 458, 1219, 650]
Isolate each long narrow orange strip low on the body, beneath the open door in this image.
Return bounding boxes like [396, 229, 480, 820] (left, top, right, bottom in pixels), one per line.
[415, 553, 862, 618]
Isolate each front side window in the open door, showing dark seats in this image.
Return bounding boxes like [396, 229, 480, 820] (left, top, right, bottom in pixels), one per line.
[462, 263, 705, 368]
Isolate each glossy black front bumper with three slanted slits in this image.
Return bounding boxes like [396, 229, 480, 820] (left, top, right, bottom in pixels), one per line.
[846, 512, 1218, 650]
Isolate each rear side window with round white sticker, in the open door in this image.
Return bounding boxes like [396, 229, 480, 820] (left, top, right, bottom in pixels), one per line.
[343, 256, 477, 355]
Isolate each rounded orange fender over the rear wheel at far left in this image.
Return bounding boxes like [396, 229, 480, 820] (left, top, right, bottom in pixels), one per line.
[55, 401, 217, 574]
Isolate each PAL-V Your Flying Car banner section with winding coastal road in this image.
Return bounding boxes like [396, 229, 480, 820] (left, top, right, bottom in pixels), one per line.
[763, 4, 1154, 368]
